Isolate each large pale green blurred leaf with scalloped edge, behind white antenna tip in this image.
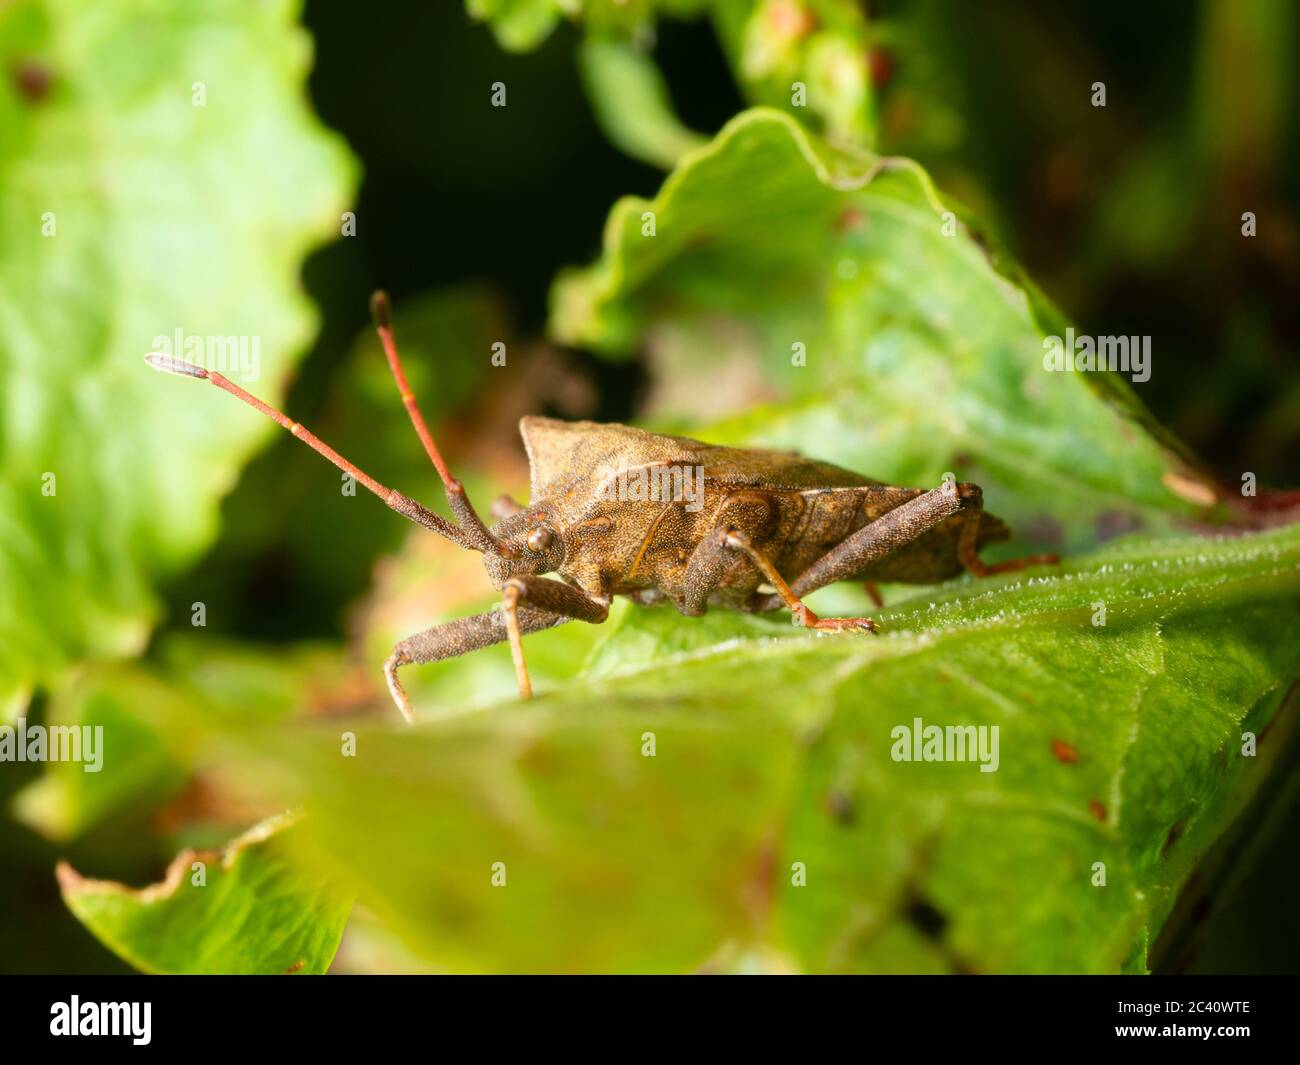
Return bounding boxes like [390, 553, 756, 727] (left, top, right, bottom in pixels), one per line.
[0, 0, 356, 713]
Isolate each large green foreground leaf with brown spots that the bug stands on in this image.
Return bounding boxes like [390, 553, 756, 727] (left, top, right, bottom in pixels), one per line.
[234, 527, 1300, 971]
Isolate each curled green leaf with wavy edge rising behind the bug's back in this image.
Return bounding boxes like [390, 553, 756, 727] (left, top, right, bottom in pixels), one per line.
[551, 109, 1219, 559]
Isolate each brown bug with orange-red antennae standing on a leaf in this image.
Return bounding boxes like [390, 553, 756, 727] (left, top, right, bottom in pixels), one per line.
[146, 294, 1057, 720]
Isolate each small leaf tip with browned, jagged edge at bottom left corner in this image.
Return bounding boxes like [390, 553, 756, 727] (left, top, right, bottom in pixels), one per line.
[59, 815, 352, 974]
